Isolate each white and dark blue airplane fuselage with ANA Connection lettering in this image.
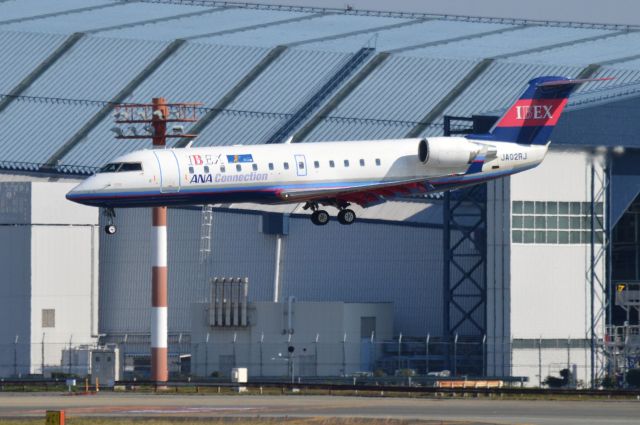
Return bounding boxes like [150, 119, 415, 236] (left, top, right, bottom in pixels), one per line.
[67, 137, 547, 207]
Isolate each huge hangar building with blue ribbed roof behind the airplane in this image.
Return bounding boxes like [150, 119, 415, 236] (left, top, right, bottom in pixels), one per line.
[0, 0, 640, 385]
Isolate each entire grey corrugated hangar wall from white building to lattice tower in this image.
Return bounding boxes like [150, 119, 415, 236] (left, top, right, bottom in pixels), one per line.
[100, 209, 450, 336]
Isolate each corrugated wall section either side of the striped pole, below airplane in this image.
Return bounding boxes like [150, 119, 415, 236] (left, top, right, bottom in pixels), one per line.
[100, 209, 275, 333]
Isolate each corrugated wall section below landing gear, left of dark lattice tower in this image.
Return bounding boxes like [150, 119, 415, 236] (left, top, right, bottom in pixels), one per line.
[281, 219, 442, 336]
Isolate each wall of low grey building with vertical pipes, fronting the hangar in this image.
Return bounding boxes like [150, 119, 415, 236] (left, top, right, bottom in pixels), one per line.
[191, 302, 393, 376]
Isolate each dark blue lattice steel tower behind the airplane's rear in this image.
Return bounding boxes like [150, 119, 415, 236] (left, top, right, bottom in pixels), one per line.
[442, 116, 496, 375]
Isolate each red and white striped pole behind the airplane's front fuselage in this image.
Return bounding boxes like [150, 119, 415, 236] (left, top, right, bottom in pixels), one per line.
[151, 98, 169, 382]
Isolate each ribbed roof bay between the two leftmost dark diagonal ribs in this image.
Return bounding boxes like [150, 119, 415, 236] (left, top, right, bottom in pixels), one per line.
[0, 37, 165, 168]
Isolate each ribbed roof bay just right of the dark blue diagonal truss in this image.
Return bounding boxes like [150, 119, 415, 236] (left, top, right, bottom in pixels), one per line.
[305, 56, 476, 141]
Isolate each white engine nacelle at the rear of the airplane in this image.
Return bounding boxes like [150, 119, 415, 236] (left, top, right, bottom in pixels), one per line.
[418, 137, 480, 171]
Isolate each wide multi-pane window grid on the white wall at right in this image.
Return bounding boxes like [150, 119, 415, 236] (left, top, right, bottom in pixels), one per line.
[511, 201, 604, 245]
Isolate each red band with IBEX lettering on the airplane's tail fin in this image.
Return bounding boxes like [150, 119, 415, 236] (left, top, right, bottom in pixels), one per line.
[498, 98, 568, 127]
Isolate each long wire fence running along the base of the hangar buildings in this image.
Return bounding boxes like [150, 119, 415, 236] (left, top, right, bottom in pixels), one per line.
[0, 334, 608, 386]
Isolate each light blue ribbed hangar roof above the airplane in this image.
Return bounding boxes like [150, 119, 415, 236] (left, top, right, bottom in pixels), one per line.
[0, 0, 640, 174]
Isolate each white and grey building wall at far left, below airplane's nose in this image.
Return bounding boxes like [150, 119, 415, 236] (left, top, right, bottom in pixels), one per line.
[0, 182, 99, 376]
